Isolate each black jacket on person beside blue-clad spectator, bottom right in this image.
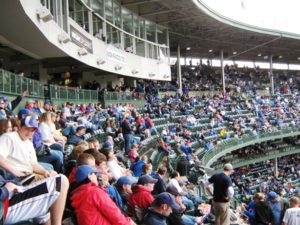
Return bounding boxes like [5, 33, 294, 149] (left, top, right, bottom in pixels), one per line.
[254, 202, 273, 225]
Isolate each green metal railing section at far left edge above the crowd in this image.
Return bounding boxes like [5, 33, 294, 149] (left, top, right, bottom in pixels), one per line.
[0, 69, 44, 98]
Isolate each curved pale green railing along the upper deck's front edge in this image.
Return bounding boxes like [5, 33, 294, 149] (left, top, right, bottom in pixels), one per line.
[202, 127, 300, 166]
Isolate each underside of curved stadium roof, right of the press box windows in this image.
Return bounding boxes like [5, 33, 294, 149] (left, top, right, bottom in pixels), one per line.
[120, 0, 300, 63]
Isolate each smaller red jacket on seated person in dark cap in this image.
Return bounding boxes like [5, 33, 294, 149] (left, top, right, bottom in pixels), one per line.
[128, 184, 154, 212]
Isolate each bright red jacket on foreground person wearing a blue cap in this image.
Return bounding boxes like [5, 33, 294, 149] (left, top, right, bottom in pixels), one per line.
[71, 183, 131, 225]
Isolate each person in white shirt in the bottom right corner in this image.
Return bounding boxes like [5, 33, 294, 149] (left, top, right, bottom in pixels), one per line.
[283, 197, 300, 225]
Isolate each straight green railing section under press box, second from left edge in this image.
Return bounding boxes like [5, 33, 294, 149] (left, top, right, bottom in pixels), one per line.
[49, 84, 98, 102]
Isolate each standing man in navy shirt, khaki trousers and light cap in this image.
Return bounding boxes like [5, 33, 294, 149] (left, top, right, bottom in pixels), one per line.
[206, 163, 234, 225]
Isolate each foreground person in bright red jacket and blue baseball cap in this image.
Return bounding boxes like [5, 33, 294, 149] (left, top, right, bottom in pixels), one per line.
[71, 165, 135, 225]
